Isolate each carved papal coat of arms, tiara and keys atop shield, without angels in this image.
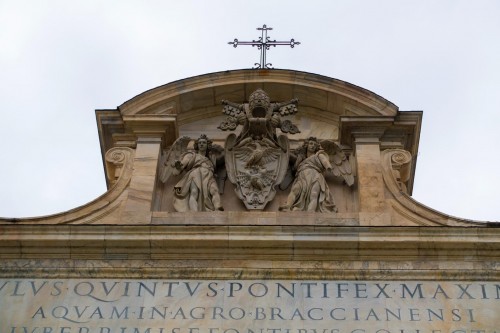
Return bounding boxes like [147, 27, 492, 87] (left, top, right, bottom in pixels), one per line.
[219, 89, 299, 210]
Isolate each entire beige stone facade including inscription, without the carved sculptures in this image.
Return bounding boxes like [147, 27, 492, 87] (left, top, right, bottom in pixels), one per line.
[0, 70, 500, 333]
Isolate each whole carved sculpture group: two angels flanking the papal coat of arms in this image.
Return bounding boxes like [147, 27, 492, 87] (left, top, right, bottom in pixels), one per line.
[160, 89, 354, 212]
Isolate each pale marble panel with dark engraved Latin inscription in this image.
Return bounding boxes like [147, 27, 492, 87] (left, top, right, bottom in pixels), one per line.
[0, 279, 500, 333]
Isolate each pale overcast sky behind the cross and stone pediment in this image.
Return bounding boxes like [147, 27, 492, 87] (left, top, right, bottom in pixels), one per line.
[0, 0, 500, 221]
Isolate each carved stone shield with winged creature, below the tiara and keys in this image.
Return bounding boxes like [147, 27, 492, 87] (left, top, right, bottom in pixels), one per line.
[225, 134, 289, 210]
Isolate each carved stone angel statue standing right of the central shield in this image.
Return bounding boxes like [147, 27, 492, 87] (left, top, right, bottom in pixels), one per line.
[280, 137, 354, 212]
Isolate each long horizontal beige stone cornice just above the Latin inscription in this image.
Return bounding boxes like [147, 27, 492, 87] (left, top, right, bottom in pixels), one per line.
[0, 224, 500, 280]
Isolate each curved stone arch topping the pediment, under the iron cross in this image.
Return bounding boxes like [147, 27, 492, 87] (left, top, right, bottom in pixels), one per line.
[119, 69, 398, 118]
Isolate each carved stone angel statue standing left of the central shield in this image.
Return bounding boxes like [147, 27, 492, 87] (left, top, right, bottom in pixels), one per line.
[160, 134, 224, 212]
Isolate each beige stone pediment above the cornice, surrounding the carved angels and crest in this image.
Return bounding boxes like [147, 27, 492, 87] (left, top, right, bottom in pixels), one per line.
[0, 70, 486, 227]
